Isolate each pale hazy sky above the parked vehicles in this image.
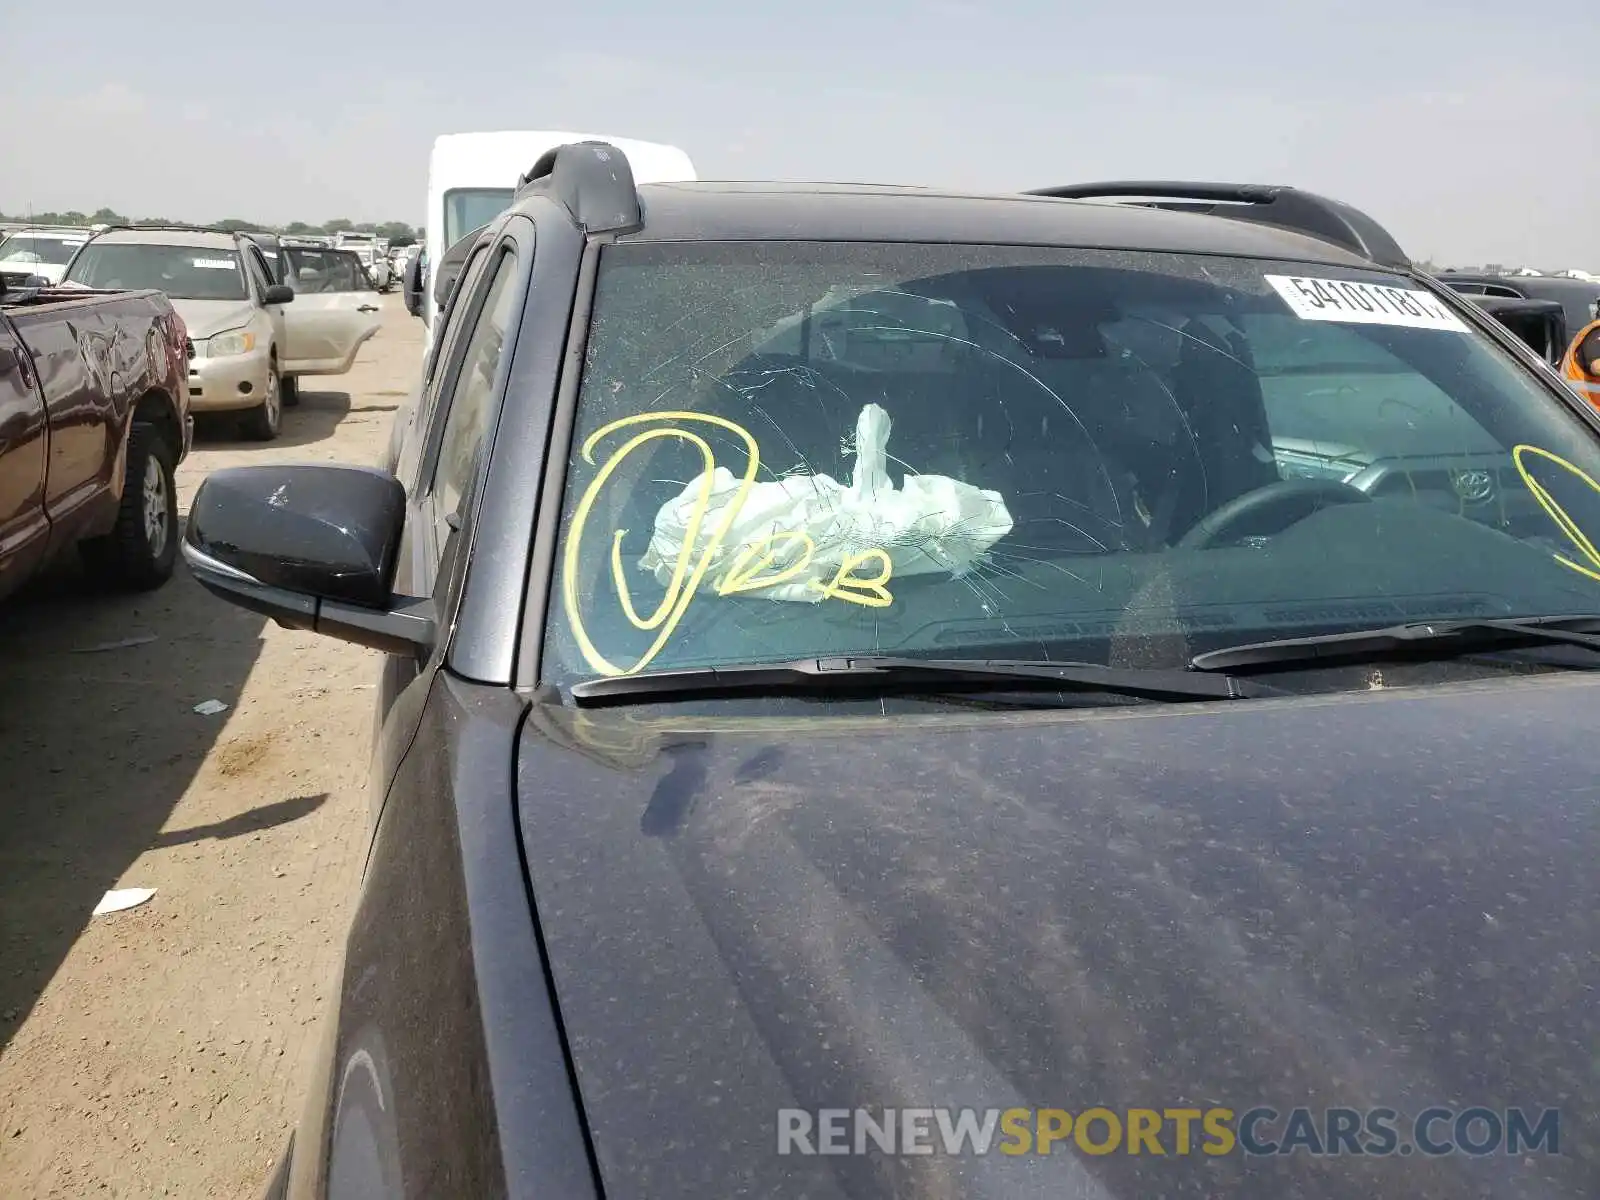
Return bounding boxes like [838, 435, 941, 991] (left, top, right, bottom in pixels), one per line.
[0, 0, 1600, 270]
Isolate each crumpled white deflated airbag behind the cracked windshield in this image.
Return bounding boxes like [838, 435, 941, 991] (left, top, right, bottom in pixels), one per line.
[638, 405, 1011, 603]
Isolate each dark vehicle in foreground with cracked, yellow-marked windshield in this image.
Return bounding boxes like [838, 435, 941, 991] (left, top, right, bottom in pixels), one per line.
[186, 144, 1600, 1200]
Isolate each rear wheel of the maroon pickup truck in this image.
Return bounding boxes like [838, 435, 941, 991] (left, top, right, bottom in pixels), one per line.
[78, 424, 178, 592]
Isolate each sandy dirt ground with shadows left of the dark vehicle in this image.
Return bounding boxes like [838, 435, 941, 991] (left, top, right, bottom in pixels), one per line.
[0, 296, 421, 1200]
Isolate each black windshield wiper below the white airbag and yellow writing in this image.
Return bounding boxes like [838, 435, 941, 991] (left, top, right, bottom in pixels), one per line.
[571, 654, 1278, 707]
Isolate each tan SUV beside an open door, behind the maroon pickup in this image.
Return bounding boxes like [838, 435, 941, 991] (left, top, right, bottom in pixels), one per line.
[66, 226, 378, 442]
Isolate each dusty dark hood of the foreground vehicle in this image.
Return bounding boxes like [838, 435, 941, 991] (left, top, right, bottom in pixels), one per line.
[518, 674, 1600, 1200]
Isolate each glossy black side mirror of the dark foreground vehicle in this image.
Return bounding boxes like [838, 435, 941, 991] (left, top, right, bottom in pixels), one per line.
[184, 466, 435, 654]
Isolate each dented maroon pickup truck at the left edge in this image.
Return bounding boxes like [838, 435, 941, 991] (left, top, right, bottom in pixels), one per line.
[0, 285, 194, 597]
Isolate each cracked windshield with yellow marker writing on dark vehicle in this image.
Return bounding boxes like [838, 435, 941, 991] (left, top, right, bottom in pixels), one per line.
[546, 243, 1600, 680]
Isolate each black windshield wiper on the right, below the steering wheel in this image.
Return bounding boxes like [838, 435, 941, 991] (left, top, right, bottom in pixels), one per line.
[1189, 616, 1600, 670]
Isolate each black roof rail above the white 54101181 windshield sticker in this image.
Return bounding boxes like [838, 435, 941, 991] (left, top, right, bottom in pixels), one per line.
[1027, 181, 1411, 267]
